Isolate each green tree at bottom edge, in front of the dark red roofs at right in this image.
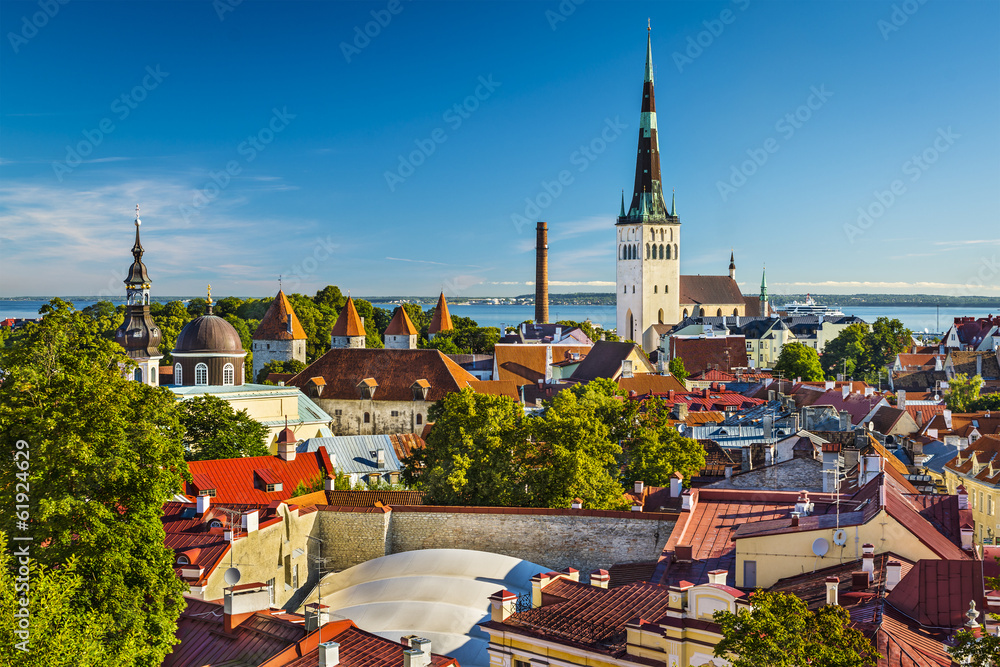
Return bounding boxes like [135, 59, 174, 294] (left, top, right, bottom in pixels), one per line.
[713, 590, 881, 667]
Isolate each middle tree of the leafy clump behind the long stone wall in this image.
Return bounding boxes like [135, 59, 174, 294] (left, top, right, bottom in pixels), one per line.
[528, 383, 627, 509]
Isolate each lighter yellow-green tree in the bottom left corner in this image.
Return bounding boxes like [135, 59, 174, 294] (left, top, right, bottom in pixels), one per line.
[0, 532, 114, 667]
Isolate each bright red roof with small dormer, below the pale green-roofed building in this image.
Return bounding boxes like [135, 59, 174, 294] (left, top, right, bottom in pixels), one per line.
[187, 447, 333, 504]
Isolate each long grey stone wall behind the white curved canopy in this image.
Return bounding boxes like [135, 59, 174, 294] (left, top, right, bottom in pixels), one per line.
[317, 506, 677, 572]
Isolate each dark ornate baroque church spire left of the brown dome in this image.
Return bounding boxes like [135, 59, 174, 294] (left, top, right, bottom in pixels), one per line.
[115, 206, 163, 387]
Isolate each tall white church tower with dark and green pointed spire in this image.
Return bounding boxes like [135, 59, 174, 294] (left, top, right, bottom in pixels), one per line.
[615, 29, 681, 352]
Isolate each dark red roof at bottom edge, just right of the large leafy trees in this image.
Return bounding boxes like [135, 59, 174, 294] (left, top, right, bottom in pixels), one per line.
[163, 596, 305, 667]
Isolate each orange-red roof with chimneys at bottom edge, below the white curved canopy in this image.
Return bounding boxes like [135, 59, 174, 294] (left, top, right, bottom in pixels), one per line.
[253, 620, 458, 667]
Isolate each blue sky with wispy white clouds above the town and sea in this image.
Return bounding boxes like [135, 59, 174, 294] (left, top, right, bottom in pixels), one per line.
[0, 0, 1000, 296]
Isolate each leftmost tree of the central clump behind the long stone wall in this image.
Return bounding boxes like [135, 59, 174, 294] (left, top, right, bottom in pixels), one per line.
[403, 389, 524, 507]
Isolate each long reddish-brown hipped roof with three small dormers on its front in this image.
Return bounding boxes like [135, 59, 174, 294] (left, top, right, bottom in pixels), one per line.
[288, 348, 476, 402]
